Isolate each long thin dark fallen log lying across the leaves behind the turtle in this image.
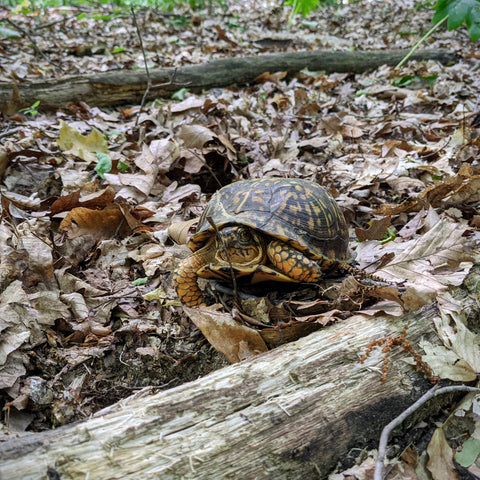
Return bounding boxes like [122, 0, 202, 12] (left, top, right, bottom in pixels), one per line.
[0, 50, 456, 112]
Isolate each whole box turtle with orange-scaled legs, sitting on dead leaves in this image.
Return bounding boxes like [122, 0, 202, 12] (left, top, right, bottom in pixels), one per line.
[173, 178, 349, 307]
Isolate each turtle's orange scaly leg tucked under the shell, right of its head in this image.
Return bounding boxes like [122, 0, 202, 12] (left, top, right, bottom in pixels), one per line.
[267, 240, 322, 283]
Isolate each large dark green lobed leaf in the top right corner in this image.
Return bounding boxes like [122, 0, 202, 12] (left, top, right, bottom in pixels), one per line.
[432, 0, 480, 42]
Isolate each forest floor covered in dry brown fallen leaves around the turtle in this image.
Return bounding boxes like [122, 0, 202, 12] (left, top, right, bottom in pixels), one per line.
[0, 1, 480, 478]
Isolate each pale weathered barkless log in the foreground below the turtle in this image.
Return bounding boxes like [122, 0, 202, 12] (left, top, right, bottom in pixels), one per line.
[0, 300, 472, 480]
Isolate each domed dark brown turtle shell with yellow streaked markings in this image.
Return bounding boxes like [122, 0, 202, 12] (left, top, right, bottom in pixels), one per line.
[188, 178, 350, 262]
